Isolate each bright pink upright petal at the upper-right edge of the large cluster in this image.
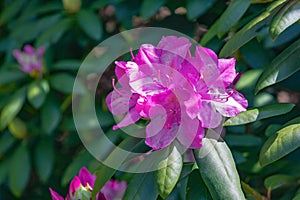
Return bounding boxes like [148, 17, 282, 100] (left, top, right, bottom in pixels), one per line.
[219, 58, 236, 87]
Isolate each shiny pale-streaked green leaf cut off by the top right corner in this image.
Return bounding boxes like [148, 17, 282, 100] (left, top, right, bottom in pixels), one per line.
[269, 0, 300, 39]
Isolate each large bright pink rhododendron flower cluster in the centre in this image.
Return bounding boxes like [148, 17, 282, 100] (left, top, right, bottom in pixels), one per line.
[106, 36, 248, 150]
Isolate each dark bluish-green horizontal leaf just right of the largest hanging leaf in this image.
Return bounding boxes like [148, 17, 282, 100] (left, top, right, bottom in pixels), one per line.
[225, 134, 262, 147]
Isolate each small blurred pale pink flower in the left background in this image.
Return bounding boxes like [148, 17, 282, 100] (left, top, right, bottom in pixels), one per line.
[13, 45, 45, 77]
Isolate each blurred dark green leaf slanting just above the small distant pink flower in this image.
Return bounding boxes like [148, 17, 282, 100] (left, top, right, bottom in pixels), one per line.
[36, 18, 72, 47]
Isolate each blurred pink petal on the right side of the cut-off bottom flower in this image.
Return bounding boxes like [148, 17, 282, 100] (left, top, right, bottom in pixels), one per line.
[101, 180, 127, 200]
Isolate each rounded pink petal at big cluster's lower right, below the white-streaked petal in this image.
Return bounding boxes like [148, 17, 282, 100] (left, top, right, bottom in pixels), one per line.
[198, 101, 222, 128]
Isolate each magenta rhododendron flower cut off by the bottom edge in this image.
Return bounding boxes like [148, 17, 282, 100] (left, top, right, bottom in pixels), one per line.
[49, 167, 127, 200]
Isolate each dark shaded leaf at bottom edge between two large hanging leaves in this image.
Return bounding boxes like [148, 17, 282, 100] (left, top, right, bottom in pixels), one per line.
[186, 170, 212, 200]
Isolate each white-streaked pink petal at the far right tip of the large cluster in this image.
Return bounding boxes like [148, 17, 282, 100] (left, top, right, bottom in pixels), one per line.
[213, 90, 248, 117]
